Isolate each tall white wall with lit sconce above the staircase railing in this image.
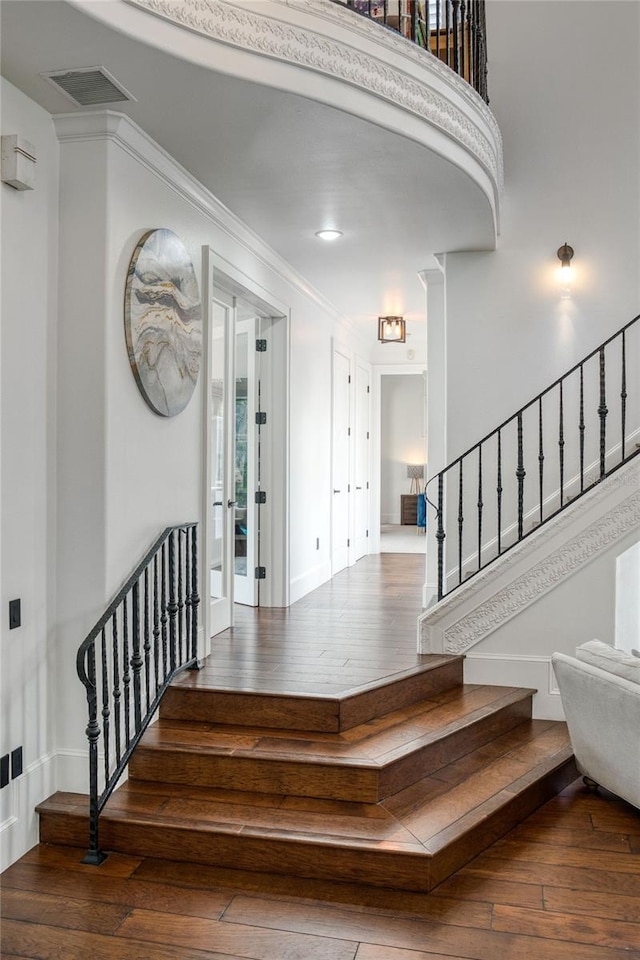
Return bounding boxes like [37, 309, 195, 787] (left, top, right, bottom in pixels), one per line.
[446, 0, 640, 461]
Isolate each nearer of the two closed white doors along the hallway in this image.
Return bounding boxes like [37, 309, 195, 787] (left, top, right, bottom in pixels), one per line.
[331, 350, 351, 575]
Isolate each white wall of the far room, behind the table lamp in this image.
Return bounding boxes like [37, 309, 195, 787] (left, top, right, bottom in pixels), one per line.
[380, 374, 426, 523]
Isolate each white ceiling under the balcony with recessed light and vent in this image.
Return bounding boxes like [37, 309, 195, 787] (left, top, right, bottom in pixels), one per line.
[0, 0, 492, 339]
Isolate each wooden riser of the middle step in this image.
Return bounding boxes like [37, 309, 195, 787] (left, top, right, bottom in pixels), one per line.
[129, 697, 531, 803]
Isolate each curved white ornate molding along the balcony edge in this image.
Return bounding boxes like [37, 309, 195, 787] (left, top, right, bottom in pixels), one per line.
[127, 0, 503, 201]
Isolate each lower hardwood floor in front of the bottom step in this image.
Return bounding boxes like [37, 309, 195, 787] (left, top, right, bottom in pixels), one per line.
[1, 781, 640, 960]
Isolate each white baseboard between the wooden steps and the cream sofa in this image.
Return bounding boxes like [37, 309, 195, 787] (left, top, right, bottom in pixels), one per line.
[464, 653, 564, 720]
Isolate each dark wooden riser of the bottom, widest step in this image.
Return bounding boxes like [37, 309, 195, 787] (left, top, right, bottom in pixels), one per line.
[40, 761, 575, 892]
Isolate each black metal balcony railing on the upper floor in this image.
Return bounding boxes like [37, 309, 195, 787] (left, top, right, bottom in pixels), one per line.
[334, 0, 489, 103]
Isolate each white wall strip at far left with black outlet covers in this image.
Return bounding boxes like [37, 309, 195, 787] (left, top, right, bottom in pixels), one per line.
[0, 80, 58, 868]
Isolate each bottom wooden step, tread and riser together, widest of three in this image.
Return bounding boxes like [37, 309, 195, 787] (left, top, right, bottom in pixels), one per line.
[38, 721, 575, 889]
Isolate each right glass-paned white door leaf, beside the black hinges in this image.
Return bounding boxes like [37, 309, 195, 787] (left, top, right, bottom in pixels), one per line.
[233, 317, 260, 607]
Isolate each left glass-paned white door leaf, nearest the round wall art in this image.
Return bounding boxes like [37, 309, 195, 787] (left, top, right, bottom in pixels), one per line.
[208, 292, 235, 636]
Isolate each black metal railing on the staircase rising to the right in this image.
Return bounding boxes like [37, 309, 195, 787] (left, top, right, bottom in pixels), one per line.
[425, 316, 640, 600]
